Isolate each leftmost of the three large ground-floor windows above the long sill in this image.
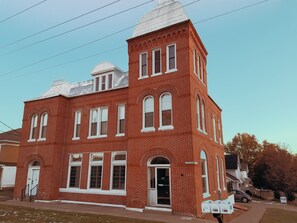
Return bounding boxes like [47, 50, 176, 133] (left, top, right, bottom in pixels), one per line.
[68, 154, 82, 188]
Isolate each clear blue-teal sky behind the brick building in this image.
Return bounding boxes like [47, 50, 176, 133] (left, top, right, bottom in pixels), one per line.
[0, 0, 297, 153]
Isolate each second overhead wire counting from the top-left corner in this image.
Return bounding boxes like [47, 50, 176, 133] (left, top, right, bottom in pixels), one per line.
[0, 0, 121, 49]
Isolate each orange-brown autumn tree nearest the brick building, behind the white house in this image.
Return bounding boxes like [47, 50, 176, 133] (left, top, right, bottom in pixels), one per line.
[225, 133, 262, 177]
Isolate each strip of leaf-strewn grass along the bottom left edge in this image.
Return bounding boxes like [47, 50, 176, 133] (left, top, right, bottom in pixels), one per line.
[0, 205, 160, 223]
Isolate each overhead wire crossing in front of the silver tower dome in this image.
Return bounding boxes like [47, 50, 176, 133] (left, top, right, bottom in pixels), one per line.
[0, 0, 200, 76]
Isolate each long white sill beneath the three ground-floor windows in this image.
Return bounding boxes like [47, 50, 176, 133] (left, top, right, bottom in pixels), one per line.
[59, 188, 126, 196]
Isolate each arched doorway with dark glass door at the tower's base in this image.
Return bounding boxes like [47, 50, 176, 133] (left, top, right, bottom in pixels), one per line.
[148, 156, 171, 207]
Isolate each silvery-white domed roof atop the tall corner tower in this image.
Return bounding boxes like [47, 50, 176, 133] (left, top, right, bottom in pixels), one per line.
[132, 0, 189, 37]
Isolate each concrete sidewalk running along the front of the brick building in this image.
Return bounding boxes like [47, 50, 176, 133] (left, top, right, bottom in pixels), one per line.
[0, 200, 215, 223]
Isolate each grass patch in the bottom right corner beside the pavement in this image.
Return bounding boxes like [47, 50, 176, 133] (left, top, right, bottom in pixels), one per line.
[260, 208, 297, 223]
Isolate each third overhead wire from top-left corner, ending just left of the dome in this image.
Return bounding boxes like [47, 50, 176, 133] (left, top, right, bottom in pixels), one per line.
[1, 0, 154, 56]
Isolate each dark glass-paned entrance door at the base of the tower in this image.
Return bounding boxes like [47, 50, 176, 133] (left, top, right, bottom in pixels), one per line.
[156, 167, 170, 205]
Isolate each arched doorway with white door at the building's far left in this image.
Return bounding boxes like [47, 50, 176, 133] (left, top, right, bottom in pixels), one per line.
[27, 161, 40, 196]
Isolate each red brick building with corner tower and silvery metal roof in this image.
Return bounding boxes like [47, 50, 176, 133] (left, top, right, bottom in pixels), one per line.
[15, 0, 227, 216]
